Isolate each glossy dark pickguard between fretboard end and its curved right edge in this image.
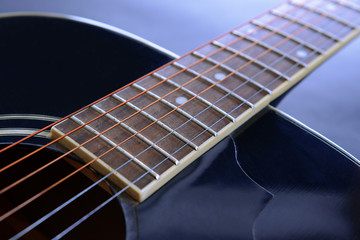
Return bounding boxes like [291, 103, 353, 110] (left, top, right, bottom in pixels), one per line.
[137, 138, 271, 239]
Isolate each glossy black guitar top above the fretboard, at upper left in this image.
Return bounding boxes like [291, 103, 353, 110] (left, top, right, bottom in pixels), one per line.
[0, 16, 172, 143]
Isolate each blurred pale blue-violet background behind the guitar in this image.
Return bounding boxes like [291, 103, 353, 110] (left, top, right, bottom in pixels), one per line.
[0, 0, 360, 158]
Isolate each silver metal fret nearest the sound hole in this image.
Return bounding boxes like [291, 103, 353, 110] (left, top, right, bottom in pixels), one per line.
[70, 116, 160, 180]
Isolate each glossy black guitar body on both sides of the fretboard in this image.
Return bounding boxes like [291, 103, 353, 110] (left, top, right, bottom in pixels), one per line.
[0, 16, 360, 239]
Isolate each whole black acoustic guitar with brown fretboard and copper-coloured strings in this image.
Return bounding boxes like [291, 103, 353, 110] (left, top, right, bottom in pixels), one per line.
[0, 0, 360, 239]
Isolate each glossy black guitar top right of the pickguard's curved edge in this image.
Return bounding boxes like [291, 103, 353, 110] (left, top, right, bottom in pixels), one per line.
[236, 110, 360, 239]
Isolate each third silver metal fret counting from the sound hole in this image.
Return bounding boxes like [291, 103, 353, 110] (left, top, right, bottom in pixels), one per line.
[112, 94, 199, 151]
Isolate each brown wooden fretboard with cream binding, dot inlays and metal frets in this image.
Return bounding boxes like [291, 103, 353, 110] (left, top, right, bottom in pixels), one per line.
[52, 0, 360, 201]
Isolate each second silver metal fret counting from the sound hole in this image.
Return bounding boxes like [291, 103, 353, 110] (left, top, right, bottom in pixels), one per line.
[91, 105, 179, 165]
